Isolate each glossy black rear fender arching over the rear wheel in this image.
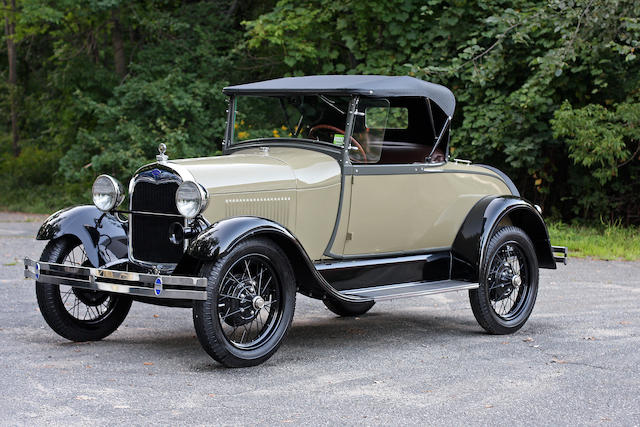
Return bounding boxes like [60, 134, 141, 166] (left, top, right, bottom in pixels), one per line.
[451, 196, 556, 282]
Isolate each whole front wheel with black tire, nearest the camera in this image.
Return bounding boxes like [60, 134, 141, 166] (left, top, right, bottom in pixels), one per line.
[193, 238, 296, 368]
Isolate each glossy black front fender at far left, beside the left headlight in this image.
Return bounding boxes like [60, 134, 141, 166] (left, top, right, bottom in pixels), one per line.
[36, 205, 129, 267]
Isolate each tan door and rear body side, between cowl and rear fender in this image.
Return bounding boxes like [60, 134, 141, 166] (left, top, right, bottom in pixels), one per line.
[344, 163, 511, 255]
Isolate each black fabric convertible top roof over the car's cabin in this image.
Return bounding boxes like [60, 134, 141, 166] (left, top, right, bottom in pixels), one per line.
[223, 75, 456, 116]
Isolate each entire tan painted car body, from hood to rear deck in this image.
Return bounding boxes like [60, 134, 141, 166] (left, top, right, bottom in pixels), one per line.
[174, 147, 511, 260]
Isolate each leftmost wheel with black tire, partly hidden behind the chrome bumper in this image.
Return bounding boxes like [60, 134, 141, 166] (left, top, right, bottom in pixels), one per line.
[36, 237, 132, 341]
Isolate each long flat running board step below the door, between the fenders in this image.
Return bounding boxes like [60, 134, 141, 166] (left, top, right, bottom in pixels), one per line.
[340, 280, 478, 301]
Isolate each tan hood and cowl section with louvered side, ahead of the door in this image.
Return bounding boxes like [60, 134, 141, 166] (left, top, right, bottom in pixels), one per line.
[174, 147, 341, 259]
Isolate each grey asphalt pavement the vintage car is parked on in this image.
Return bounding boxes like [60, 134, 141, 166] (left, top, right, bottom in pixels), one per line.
[0, 214, 640, 426]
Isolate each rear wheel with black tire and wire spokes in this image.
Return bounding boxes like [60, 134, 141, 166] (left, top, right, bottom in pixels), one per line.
[469, 226, 538, 335]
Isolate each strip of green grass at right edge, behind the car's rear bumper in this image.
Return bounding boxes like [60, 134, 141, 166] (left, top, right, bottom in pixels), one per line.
[547, 222, 640, 261]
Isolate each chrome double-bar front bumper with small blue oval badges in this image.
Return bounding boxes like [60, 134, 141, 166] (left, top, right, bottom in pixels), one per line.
[24, 258, 207, 301]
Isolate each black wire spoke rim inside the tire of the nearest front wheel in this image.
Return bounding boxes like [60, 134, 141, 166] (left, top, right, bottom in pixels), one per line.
[217, 254, 282, 349]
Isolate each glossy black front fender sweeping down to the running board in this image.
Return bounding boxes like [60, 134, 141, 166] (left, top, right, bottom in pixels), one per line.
[186, 216, 368, 302]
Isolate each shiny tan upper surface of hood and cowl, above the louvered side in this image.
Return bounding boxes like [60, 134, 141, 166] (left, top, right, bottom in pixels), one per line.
[167, 147, 340, 195]
